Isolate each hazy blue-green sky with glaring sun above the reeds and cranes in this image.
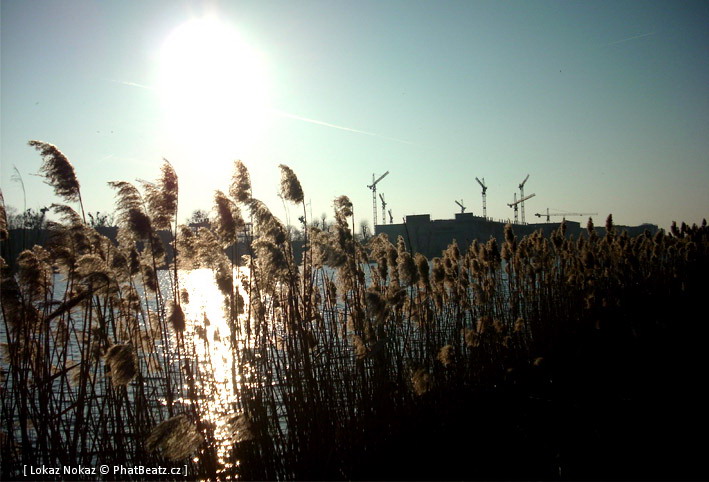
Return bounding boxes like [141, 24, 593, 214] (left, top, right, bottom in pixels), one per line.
[0, 0, 709, 232]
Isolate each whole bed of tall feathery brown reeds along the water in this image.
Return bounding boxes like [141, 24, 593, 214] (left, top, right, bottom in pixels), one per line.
[0, 141, 709, 480]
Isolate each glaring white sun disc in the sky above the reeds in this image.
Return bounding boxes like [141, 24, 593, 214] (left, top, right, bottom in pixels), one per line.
[158, 17, 268, 162]
